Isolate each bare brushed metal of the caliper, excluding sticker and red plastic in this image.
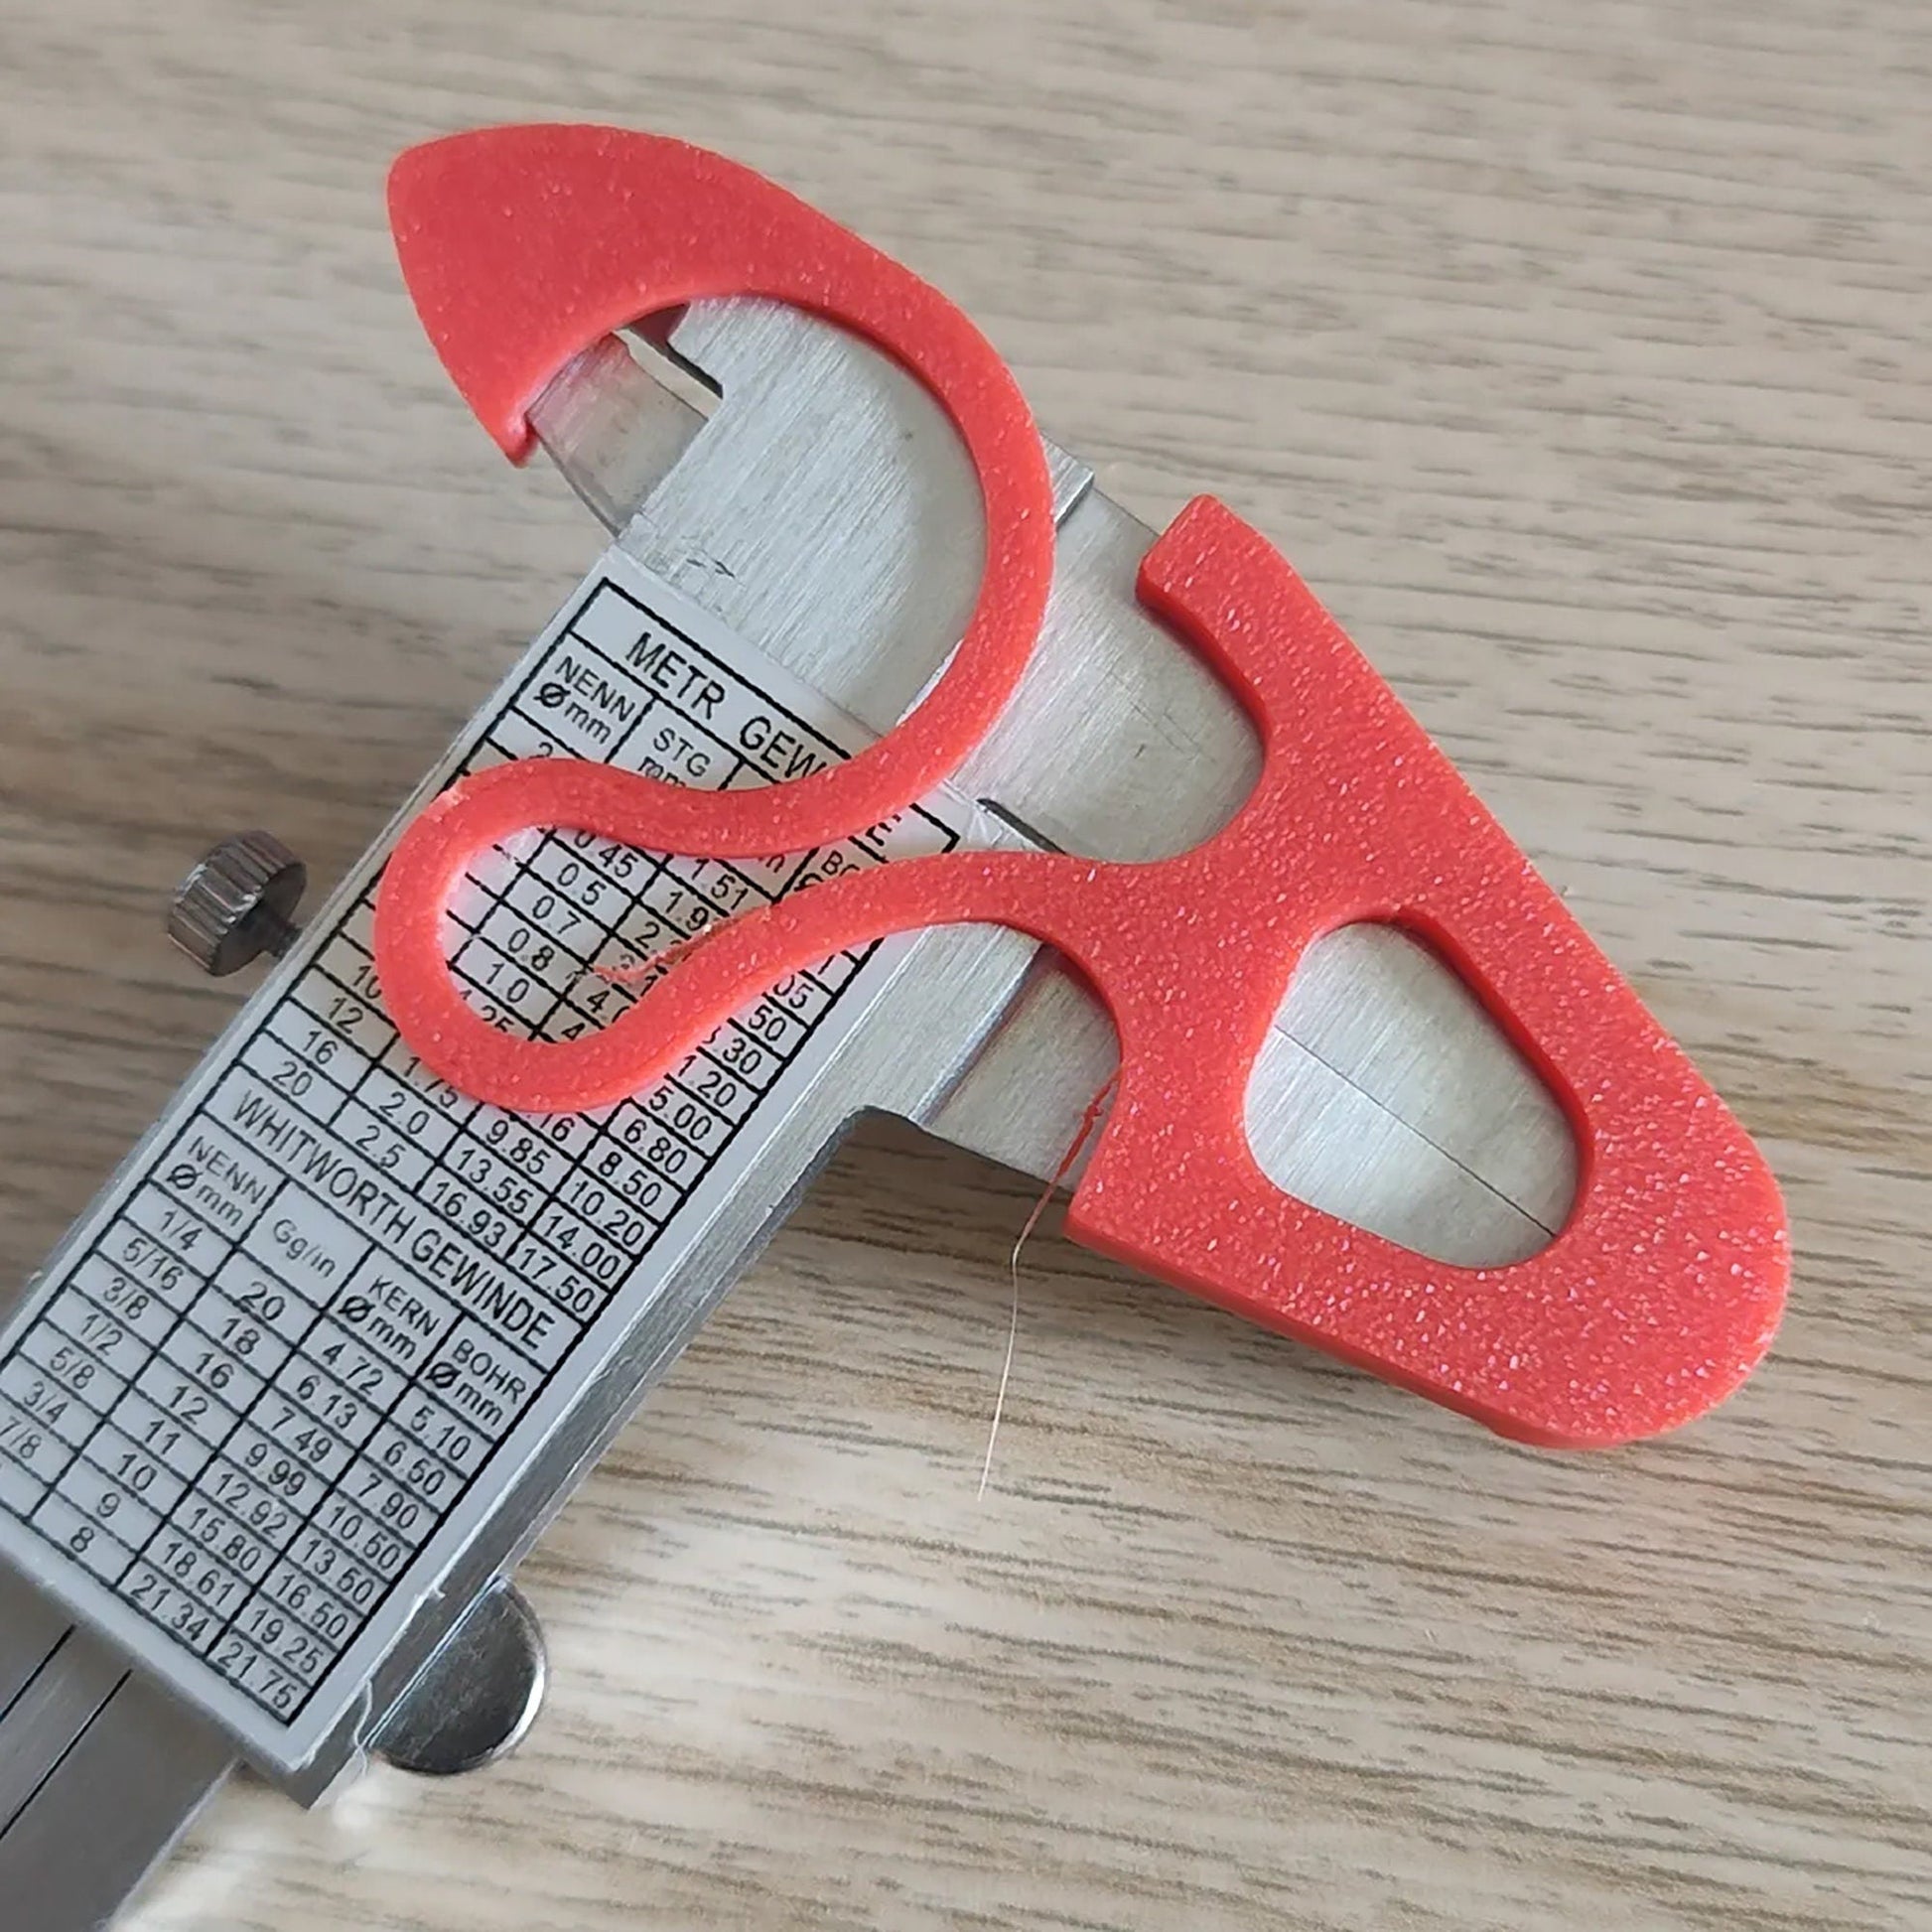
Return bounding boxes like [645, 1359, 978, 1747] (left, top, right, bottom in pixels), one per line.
[0, 272, 1575, 1932]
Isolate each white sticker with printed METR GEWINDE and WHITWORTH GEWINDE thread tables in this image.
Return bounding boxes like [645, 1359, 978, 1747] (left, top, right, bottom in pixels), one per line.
[0, 551, 966, 1764]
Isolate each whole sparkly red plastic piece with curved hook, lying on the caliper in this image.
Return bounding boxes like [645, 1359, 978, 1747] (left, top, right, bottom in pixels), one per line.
[375, 127, 1789, 1448]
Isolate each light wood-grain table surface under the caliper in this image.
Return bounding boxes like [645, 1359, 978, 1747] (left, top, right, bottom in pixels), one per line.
[0, 0, 1932, 1932]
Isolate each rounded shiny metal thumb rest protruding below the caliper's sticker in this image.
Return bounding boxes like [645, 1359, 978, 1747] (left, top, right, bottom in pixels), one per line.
[375, 1583, 551, 1777]
